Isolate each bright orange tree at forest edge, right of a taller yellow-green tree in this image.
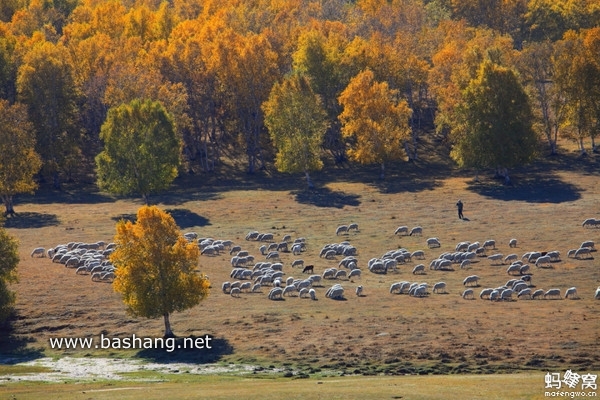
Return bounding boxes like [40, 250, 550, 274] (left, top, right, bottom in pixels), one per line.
[339, 70, 412, 179]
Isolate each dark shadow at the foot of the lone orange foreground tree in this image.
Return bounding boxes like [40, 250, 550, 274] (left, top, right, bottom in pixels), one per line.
[136, 335, 233, 364]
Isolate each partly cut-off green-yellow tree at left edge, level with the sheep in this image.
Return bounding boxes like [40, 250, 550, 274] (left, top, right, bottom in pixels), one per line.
[0, 223, 19, 321]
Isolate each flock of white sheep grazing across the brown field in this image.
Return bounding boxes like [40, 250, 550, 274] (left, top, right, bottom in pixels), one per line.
[31, 218, 600, 301]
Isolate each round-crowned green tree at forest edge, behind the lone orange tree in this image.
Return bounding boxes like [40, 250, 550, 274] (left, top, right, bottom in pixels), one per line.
[96, 100, 181, 204]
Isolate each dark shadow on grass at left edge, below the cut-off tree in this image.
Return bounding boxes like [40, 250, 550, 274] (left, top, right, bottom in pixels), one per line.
[0, 314, 45, 365]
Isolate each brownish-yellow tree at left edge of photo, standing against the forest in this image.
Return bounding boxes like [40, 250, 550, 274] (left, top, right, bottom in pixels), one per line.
[0, 99, 42, 215]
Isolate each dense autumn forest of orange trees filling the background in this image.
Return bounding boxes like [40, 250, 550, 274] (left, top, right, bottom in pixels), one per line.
[0, 0, 600, 195]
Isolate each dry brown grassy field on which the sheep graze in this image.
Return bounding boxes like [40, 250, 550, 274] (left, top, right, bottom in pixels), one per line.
[0, 138, 600, 398]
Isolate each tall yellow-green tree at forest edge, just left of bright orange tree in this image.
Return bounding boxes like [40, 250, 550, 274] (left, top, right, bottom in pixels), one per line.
[263, 75, 328, 188]
